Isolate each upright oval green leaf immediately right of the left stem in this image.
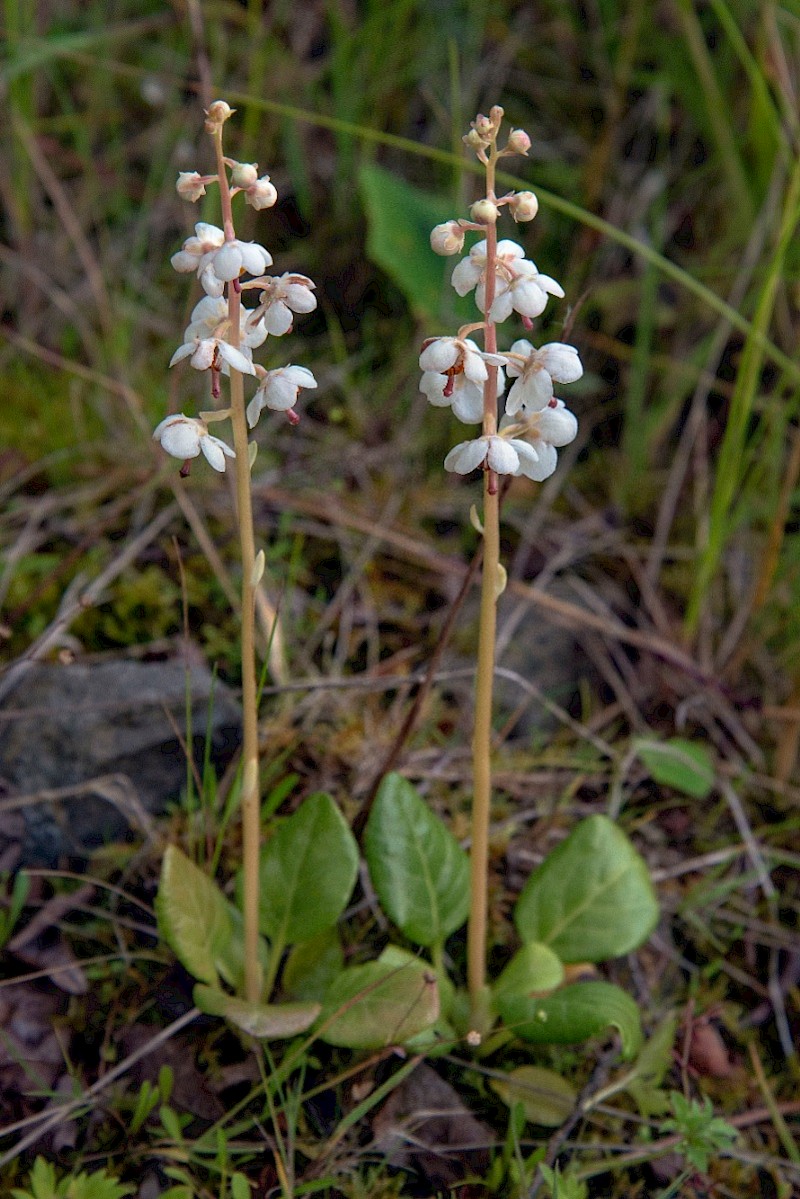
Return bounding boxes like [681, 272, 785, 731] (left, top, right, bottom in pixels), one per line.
[259, 794, 359, 945]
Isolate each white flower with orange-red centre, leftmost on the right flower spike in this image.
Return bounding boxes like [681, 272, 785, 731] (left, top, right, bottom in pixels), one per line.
[420, 337, 505, 424]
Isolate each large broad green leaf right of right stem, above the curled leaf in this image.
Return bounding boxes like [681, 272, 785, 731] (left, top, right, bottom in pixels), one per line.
[515, 815, 658, 962]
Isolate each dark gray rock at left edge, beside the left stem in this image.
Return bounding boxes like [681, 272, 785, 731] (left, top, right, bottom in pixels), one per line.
[0, 657, 241, 866]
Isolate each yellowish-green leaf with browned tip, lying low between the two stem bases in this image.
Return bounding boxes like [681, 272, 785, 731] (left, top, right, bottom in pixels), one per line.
[319, 959, 439, 1049]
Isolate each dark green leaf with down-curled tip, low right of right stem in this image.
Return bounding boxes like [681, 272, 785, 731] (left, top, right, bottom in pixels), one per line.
[498, 982, 642, 1058]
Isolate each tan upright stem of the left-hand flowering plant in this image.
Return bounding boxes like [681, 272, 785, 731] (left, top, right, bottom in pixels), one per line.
[213, 129, 261, 1004]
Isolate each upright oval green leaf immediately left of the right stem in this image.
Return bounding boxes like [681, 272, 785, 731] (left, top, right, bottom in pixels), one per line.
[363, 775, 469, 946]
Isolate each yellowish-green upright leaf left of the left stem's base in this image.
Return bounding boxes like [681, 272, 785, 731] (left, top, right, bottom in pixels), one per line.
[156, 845, 234, 984]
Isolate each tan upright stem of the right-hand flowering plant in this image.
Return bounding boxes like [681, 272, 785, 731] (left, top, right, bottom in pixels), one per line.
[467, 145, 500, 1034]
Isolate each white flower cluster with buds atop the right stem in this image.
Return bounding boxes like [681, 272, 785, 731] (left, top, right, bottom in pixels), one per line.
[420, 107, 583, 481]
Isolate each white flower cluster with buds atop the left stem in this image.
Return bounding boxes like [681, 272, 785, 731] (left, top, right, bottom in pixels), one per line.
[154, 101, 317, 474]
